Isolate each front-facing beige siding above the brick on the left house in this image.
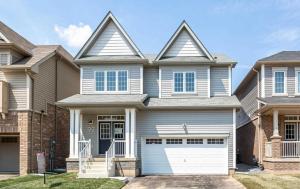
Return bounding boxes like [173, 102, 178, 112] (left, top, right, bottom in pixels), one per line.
[0, 72, 28, 110]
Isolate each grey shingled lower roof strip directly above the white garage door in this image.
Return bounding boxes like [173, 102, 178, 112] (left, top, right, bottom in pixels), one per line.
[145, 96, 241, 109]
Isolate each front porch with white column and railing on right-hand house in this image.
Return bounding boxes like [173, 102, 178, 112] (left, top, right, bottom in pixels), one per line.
[261, 107, 300, 170]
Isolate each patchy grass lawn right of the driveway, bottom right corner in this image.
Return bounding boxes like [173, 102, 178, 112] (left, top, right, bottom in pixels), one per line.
[234, 173, 300, 189]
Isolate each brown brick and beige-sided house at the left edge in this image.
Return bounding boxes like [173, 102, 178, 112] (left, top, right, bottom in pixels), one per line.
[0, 22, 80, 175]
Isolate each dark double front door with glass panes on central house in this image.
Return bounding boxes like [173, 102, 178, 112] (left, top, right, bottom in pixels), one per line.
[99, 122, 125, 155]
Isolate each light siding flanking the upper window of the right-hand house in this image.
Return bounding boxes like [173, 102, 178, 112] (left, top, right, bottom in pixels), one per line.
[265, 65, 295, 97]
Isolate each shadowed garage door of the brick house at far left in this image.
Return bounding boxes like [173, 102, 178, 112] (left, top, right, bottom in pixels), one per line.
[0, 136, 19, 172]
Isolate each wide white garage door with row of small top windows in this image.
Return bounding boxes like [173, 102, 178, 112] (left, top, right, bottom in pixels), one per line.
[141, 138, 228, 175]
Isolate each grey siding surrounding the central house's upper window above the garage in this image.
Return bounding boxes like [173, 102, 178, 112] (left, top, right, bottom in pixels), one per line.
[161, 66, 208, 98]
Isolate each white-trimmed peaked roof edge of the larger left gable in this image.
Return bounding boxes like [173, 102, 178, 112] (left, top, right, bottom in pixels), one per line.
[75, 11, 145, 60]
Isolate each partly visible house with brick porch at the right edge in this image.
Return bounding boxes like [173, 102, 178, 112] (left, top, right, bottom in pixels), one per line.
[234, 51, 300, 170]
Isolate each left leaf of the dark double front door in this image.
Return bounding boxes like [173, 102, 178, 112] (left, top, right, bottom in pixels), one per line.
[99, 122, 112, 154]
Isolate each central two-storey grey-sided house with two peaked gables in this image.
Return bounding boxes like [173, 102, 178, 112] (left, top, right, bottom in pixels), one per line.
[57, 12, 240, 177]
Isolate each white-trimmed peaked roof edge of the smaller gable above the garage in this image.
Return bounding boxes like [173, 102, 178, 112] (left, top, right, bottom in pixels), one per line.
[155, 21, 214, 61]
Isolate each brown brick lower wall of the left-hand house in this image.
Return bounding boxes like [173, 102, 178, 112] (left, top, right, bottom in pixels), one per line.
[0, 104, 69, 175]
